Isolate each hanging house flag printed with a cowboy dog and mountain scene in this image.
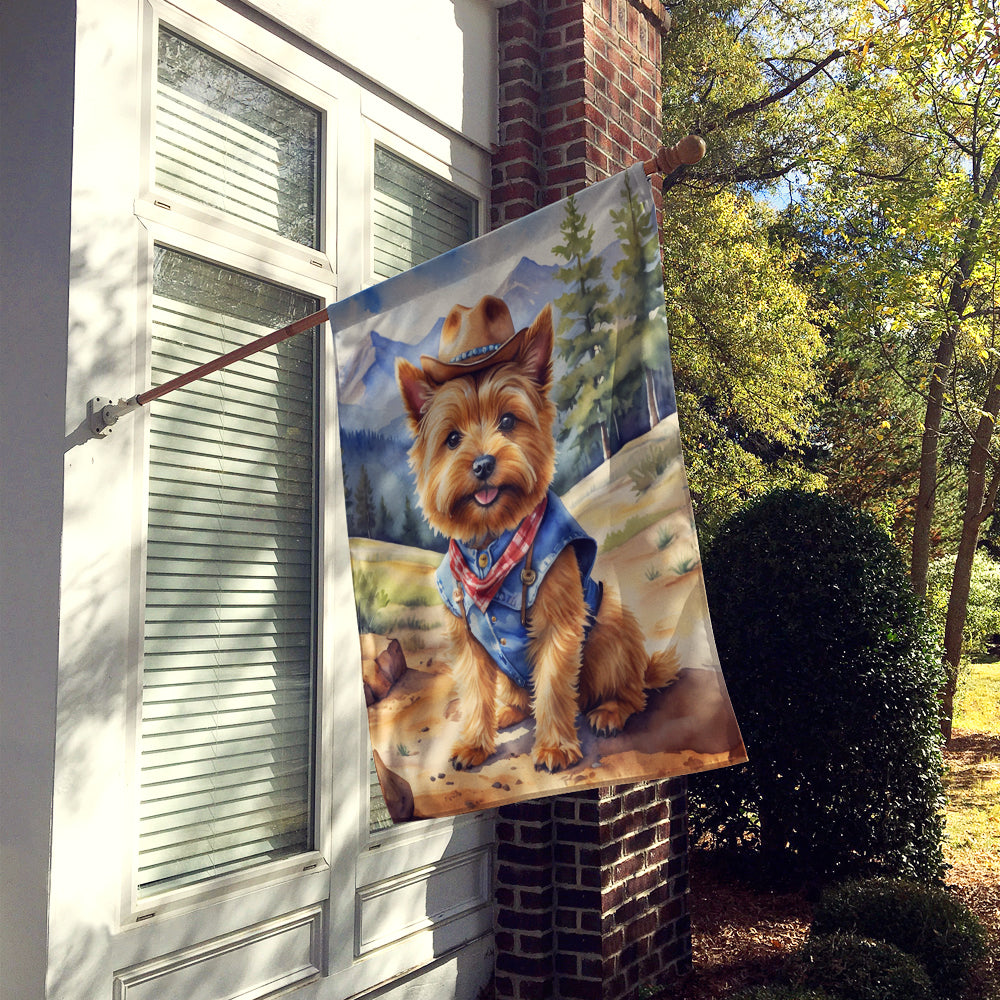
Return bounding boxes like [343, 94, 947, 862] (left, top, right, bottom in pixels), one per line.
[329, 164, 746, 822]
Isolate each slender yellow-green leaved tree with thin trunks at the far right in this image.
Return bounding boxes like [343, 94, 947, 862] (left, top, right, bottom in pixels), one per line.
[815, 0, 1000, 734]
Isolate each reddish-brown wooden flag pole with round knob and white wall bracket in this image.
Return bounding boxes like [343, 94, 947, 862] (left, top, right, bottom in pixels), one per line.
[87, 135, 705, 437]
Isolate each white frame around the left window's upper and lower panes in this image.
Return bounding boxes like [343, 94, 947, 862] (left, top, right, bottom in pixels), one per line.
[120, 2, 338, 927]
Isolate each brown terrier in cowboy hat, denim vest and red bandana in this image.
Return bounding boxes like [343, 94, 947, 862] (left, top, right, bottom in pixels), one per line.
[396, 296, 678, 772]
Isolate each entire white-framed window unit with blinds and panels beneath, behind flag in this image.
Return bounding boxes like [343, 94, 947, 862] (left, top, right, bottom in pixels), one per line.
[113, 0, 492, 1000]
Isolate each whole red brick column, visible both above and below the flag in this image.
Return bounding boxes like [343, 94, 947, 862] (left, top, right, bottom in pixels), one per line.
[492, 0, 691, 1000]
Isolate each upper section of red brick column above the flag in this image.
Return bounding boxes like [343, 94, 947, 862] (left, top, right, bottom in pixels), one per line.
[492, 0, 669, 227]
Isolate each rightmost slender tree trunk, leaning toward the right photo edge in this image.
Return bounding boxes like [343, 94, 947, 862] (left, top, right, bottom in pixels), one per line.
[941, 375, 1000, 740]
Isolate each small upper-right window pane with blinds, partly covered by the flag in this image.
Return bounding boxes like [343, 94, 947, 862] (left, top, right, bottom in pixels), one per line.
[372, 146, 478, 278]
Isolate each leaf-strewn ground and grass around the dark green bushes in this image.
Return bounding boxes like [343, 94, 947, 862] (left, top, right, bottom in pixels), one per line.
[661, 730, 1000, 1000]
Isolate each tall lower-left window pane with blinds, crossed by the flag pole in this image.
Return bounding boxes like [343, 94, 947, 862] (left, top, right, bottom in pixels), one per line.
[138, 247, 318, 895]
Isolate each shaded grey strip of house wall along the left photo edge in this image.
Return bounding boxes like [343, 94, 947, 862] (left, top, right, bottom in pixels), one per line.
[0, 0, 75, 998]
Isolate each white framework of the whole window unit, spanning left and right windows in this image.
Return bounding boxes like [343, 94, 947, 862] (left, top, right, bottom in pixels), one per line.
[112, 0, 493, 1000]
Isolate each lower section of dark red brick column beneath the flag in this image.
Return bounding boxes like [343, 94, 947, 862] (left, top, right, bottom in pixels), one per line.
[495, 779, 691, 1000]
